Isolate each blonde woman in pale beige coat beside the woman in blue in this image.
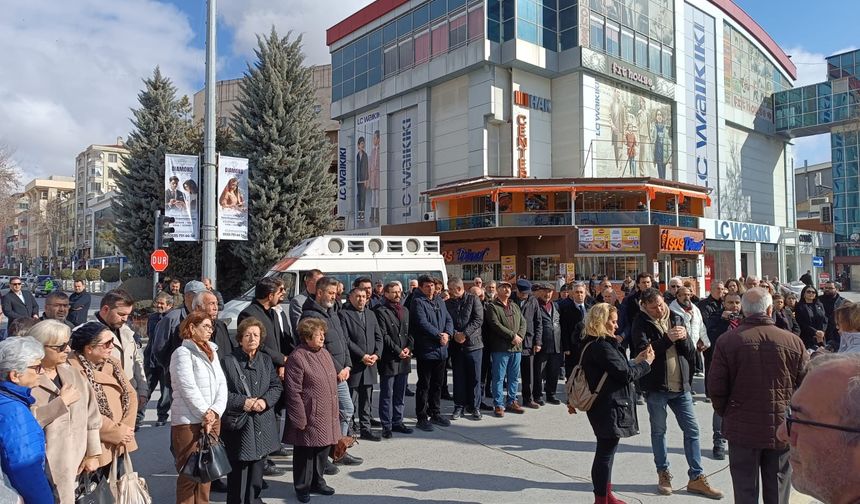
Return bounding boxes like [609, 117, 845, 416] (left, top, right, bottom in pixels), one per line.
[27, 320, 102, 504]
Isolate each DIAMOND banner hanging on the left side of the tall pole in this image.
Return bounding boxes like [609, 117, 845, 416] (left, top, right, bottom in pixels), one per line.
[164, 154, 200, 241]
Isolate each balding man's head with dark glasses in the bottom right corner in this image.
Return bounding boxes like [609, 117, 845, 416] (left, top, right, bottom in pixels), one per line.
[777, 353, 860, 504]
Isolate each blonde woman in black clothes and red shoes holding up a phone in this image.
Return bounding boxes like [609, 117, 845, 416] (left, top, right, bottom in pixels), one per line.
[568, 303, 654, 504]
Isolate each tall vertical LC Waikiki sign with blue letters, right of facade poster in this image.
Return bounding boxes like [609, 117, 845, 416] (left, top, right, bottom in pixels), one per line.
[684, 4, 719, 217]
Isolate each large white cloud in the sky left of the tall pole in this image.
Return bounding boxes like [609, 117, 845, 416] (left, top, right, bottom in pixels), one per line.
[0, 0, 204, 183]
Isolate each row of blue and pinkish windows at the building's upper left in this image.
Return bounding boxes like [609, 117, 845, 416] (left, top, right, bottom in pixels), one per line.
[331, 0, 488, 101]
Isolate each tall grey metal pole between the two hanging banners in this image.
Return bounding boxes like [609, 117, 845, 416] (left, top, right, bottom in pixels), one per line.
[200, 0, 218, 287]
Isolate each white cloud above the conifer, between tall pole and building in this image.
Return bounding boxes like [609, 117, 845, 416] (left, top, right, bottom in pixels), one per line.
[218, 0, 371, 65]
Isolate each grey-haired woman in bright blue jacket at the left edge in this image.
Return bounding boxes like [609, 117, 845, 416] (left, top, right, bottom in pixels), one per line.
[0, 337, 54, 504]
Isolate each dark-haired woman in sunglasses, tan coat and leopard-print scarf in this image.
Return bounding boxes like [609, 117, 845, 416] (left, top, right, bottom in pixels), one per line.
[69, 322, 137, 476]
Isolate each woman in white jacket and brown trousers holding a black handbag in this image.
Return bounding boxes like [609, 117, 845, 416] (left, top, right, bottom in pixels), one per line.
[170, 311, 227, 504]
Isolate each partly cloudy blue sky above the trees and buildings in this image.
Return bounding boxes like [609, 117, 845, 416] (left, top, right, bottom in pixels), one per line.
[0, 0, 860, 184]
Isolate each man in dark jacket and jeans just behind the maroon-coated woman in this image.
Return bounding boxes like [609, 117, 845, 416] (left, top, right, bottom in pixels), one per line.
[299, 277, 364, 466]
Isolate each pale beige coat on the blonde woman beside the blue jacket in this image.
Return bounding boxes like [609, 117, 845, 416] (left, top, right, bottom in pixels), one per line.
[32, 364, 102, 504]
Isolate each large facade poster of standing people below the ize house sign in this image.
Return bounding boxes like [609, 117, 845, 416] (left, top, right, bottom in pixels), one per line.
[583, 75, 675, 180]
